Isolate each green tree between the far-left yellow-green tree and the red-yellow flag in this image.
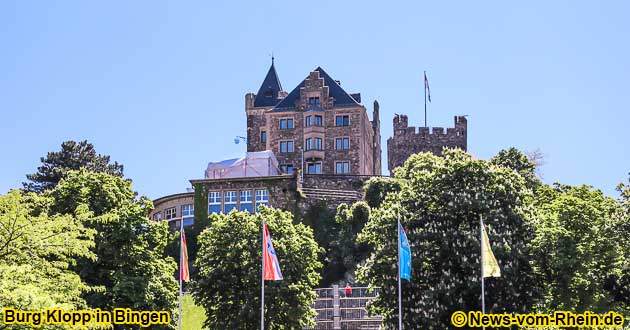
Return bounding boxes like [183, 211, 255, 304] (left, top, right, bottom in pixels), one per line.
[47, 169, 178, 328]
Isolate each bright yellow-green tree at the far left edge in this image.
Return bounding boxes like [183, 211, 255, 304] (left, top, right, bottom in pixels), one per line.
[0, 190, 94, 318]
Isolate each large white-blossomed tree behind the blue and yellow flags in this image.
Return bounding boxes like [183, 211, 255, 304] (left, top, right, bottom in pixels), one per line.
[359, 150, 537, 329]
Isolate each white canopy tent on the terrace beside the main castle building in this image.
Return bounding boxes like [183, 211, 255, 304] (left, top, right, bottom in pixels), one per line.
[205, 150, 282, 179]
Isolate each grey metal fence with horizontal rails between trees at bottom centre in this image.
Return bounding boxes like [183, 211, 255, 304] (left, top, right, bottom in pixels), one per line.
[306, 285, 382, 330]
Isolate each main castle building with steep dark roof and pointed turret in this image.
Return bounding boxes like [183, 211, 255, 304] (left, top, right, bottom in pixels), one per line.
[245, 65, 381, 175]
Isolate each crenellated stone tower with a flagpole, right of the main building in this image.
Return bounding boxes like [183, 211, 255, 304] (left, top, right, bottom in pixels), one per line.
[387, 115, 468, 175]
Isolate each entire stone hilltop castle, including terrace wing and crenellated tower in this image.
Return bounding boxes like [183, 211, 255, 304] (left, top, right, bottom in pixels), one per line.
[150, 59, 467, 228]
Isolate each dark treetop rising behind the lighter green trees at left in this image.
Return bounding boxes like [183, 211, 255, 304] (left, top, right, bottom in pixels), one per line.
[22, 141, 123, 193]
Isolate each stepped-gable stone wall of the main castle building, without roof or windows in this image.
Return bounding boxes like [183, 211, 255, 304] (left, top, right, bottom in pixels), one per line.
[246, 71, 381, 175]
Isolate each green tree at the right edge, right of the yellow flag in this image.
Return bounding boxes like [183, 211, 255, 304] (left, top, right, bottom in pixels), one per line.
[533, 185, 628, 313]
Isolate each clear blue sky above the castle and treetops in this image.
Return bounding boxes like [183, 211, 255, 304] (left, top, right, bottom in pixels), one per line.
[0, 0, 630, 198]
